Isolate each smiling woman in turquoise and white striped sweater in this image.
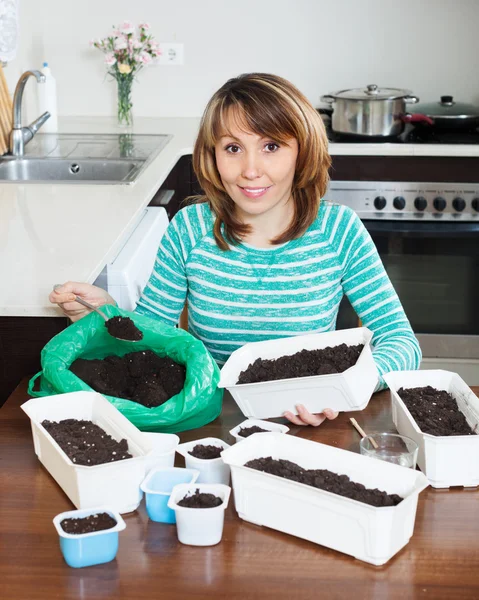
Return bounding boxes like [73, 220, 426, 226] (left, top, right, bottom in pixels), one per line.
[50, 73, 421, 425]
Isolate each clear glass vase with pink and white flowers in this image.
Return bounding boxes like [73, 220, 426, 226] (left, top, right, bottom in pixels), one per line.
[90, 21, 161, 128]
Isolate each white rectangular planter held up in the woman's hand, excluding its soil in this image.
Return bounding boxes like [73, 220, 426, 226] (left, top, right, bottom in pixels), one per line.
[218, 327, 378, 419]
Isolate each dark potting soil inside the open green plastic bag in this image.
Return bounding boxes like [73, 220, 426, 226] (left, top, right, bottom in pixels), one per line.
[70, 350, 186, 408]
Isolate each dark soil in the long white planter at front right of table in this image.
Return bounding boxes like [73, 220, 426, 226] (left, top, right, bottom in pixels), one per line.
[245, 456, 403, 506]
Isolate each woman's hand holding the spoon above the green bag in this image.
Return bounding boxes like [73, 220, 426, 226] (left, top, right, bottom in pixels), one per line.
[48, 281, 115, 322]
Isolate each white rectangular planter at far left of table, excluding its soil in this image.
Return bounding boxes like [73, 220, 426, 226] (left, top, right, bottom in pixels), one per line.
[22, 392, 152, 513]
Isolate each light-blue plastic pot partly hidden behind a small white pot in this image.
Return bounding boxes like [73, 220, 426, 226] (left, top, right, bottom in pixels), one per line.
[140, 467, 200, 523]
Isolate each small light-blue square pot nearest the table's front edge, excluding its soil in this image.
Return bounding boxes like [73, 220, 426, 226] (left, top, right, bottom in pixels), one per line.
[53, 506, 126, 568]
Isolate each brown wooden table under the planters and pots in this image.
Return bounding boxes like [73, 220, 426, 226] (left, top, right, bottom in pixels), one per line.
[0, 382, 479, 600]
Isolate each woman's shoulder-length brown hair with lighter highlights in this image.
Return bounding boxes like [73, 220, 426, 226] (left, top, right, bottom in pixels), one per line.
[192, 73, 331, 250]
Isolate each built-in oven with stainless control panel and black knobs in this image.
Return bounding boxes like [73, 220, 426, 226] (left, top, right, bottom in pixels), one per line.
[325, 155, 479, 385]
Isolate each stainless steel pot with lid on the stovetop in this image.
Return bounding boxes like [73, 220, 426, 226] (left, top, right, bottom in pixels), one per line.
[321, 84, 433, 137]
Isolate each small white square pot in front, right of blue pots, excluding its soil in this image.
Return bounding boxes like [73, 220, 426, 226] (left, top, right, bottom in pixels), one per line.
[168, 483, 231, 546]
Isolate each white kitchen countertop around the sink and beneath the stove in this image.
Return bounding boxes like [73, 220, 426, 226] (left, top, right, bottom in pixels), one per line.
[0, 117, 479, 316]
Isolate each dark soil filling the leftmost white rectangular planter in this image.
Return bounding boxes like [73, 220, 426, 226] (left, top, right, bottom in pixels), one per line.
[42, 419, 132, 467]
